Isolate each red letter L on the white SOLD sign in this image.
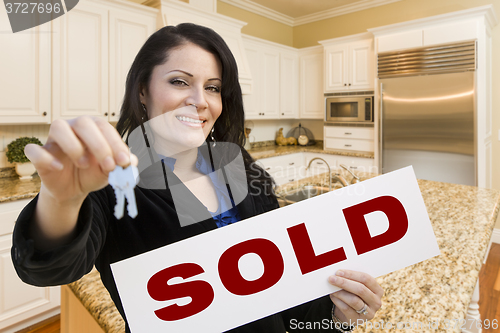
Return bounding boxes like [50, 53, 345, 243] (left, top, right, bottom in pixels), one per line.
[287, 223, 347, 275]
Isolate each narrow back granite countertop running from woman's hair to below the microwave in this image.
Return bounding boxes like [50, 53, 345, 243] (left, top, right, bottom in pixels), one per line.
[248, 141, 374, 160]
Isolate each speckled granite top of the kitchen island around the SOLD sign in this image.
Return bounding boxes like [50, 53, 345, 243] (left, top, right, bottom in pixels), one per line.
[62, 170, 500, 333]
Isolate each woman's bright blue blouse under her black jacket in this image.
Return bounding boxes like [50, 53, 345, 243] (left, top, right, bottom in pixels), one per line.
[160, 149, 241, 228]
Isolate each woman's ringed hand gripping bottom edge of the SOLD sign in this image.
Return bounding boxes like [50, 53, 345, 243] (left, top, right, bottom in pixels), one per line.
[328, 270, 384, 325]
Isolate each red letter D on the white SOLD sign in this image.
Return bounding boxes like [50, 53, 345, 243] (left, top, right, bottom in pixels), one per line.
[342, 196, 408, 255]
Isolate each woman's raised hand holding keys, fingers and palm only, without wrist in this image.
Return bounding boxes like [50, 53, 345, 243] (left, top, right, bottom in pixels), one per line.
[25, 117, 137, 202]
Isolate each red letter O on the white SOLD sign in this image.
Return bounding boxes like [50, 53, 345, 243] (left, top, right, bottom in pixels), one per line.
[219, 238, 285, 296]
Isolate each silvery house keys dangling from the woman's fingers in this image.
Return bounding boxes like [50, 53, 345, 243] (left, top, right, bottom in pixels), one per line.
[108, 165, 139, 220]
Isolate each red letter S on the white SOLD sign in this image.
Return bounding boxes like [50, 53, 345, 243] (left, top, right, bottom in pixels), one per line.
[148, 263, 214, 321]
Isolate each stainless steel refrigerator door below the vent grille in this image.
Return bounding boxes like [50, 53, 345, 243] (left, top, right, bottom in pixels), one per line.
[379, 40, 477, 185]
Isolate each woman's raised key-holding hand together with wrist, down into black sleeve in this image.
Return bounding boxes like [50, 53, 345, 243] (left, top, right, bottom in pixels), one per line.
[24, 117, 137, 245]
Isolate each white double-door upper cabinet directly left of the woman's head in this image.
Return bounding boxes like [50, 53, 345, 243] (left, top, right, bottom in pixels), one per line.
[52, 1, 157, 121]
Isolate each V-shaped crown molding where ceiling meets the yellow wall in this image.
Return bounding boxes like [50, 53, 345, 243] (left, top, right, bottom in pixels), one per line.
[220, 0, 401, 27]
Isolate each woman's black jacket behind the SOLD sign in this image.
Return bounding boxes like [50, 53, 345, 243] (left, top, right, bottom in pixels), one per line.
[11, 165, 335, 333]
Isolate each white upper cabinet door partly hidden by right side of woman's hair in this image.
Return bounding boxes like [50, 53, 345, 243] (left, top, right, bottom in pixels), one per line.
[243, 45, 262, 119]
